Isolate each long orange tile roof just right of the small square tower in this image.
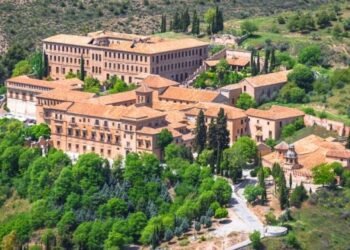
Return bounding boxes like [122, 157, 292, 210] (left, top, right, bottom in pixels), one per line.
[159, 86, 220, 102]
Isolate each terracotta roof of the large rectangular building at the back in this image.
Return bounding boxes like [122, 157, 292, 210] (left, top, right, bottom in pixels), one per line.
[43, 32, 208, 54]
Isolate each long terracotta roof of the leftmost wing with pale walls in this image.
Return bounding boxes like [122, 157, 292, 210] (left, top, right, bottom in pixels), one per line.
[6, 75, 82, 89]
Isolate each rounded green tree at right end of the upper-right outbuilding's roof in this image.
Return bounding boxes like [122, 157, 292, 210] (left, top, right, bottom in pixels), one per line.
[288, 64, 315, 92]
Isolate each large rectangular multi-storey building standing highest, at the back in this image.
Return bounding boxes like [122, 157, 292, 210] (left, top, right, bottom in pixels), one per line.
[43, 31, 208, 83]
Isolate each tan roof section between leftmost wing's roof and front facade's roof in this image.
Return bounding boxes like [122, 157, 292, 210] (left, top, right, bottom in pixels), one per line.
[37, 89, 95, 102]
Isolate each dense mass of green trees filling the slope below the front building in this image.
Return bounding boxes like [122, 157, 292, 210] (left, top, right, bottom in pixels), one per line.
[0, 119, 232, 249]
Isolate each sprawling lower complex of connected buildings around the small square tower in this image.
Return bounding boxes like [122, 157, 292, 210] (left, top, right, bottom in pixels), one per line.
[6, 72, 303, 159]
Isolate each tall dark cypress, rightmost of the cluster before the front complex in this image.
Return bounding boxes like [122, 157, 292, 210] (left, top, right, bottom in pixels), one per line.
[216, 108, 230, 174]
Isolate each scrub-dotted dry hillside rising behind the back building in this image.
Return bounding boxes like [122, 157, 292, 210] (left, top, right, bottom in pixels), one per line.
[0, 0, 329, 53]
